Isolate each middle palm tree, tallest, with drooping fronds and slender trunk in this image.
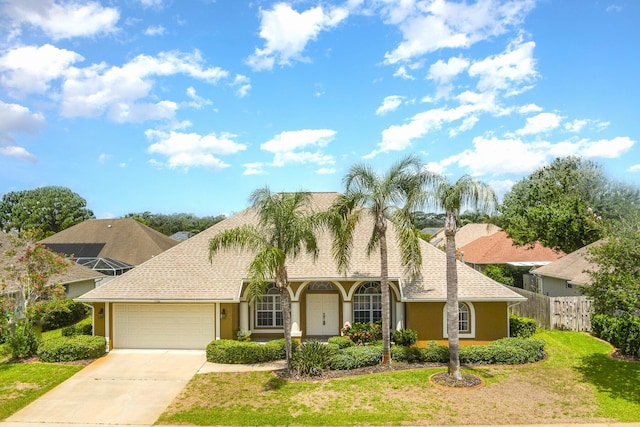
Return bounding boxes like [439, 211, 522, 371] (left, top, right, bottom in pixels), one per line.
[329, 156, 432, 364]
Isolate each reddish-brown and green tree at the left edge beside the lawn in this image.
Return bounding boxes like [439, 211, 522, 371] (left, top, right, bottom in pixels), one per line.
[0, 236, 69, 358]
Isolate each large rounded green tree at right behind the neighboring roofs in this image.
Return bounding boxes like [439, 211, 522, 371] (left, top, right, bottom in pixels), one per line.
[500, 157, 640, 253]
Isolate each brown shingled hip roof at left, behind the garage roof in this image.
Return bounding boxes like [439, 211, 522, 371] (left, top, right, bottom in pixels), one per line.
[40, 218, 178, 265]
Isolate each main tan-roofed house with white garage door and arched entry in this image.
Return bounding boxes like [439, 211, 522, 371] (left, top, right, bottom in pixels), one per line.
[77, 193, 525, 349]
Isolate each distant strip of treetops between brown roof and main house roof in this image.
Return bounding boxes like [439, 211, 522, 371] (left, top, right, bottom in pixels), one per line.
[125, 211, 225, 236]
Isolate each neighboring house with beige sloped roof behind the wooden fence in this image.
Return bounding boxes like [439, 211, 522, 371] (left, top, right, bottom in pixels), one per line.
[531, 240, 602, 297]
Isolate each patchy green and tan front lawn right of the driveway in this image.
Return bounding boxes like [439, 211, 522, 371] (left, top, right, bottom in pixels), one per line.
[158, 331, 640, 425]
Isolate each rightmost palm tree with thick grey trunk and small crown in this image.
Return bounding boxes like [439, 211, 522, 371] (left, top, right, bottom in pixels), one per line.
[434, 176, 498, 379]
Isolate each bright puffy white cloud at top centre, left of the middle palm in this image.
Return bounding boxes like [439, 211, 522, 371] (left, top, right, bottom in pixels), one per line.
[246, 3, 349, 71]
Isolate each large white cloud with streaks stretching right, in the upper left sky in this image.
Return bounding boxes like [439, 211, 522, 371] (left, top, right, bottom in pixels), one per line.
[61, 51, 228, 122]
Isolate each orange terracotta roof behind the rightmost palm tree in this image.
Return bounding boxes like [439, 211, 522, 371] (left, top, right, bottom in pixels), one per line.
[459, 231, 565, 264]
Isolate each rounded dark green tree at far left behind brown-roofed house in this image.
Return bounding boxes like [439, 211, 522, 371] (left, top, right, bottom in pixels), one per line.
[0, 186, 94, 238]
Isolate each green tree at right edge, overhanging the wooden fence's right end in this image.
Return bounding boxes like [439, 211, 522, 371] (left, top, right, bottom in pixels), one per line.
[584, 211, 640, 317]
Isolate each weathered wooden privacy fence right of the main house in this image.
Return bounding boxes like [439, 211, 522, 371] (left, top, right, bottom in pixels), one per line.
[508, 286, 591, 332]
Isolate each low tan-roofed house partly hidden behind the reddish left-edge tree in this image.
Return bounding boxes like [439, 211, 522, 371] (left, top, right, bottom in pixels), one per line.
[0, 231, 105, 298]
